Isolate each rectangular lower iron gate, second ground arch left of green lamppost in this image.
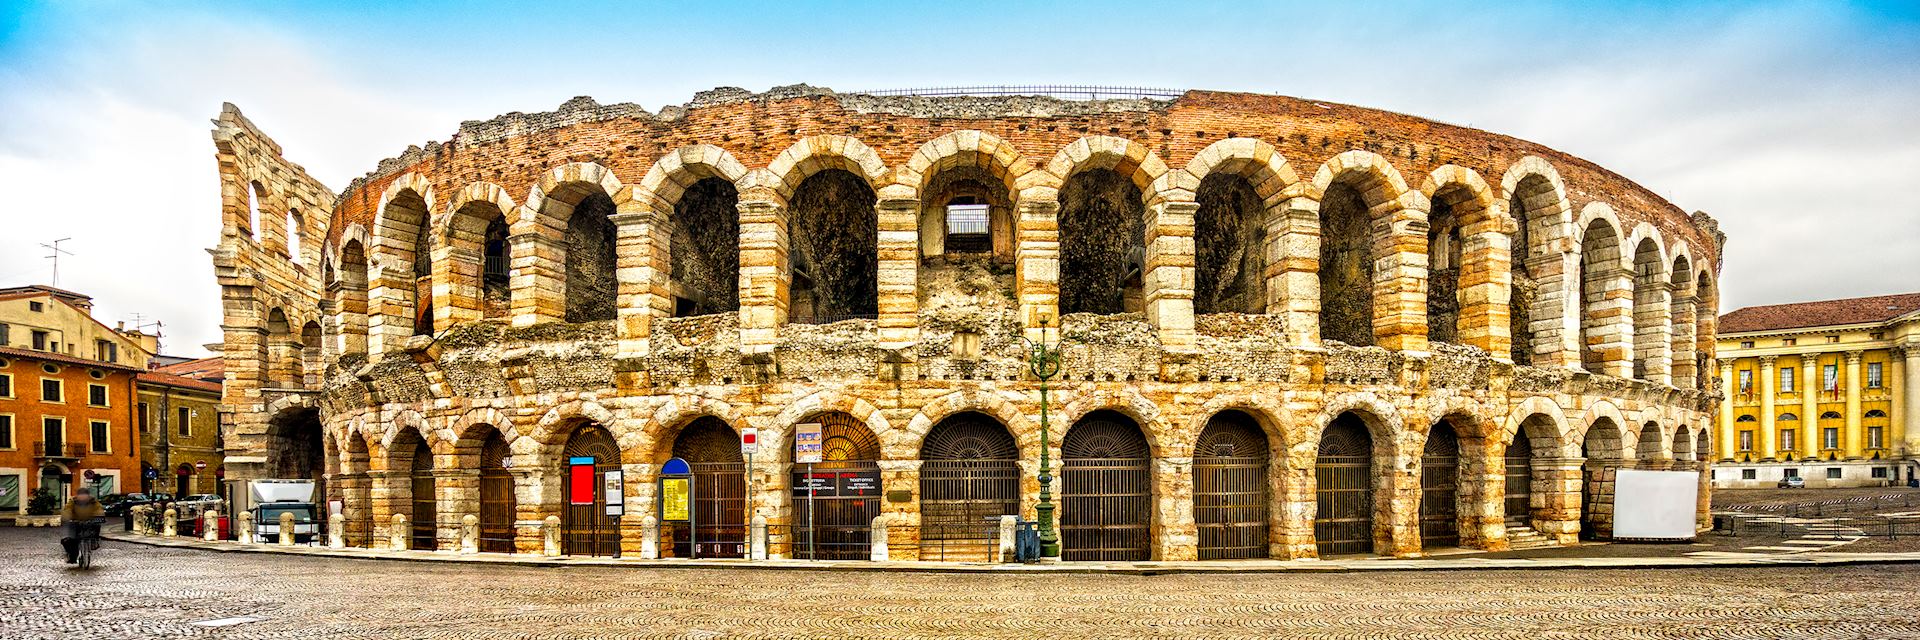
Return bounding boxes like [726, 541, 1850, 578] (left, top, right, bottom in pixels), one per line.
[793, 461, 879, 559]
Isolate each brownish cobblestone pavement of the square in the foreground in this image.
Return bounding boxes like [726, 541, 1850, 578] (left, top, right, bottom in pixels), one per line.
[11, 529, 1920, 640]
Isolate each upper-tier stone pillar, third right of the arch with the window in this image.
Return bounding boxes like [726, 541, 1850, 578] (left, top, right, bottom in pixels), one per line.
[1265, 198, 1321, 350]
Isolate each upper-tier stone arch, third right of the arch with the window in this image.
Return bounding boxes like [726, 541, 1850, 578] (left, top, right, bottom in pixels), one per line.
[1308, 150, 1428, 350]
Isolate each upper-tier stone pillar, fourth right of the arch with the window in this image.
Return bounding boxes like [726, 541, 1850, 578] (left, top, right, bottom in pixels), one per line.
[1373, 208, 1427, 351]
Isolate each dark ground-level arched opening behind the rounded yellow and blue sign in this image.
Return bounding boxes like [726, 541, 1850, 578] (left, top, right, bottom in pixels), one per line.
[672, 415, 741, 557]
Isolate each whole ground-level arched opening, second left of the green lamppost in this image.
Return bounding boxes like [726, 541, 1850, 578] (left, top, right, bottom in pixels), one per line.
[785, 411, 879, 559]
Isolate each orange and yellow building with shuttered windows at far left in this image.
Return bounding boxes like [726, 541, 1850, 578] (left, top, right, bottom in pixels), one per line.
[0, 286, 148, 519]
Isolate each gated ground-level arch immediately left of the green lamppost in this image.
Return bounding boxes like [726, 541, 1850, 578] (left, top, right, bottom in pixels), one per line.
[920, 411, 1020, 561]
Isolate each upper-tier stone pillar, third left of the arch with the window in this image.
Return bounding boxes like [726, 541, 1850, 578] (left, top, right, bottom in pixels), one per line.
[609, 200, 674, 361]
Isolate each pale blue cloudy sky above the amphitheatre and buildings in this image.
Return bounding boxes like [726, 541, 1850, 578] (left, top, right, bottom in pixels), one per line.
[0, 0, 1920, 354]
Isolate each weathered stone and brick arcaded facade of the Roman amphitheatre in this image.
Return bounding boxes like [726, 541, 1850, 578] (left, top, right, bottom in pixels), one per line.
[213, 85, 1724, 559]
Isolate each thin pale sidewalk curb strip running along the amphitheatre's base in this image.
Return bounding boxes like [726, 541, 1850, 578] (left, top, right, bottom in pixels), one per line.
[106, 532, 1920, 577]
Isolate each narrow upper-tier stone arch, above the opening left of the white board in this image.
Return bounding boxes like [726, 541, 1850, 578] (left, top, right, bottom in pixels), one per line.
[1576, 202, 1634, 379]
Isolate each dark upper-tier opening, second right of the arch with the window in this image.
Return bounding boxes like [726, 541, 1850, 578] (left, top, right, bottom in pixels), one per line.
[1194, 173, 1267, 313]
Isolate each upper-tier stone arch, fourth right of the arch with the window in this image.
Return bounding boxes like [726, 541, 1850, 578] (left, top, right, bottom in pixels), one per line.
[1421, 165, 1513, 356]
